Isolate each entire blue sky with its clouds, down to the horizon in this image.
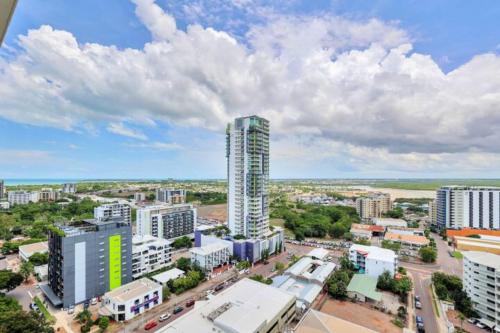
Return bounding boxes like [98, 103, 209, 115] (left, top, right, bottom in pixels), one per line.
[0, 0, 500, 178]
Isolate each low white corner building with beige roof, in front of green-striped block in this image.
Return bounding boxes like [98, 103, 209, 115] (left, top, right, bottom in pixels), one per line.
[99, 278, 163, 321]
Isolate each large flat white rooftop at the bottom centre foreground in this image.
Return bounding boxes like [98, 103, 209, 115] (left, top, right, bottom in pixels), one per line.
[157, 279, 295, 333]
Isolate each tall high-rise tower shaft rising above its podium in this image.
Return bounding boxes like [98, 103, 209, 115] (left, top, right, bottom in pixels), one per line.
[226, 116, 269, 238]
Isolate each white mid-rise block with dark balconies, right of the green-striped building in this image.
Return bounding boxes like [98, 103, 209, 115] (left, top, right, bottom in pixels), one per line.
[137, 204, 197, 239]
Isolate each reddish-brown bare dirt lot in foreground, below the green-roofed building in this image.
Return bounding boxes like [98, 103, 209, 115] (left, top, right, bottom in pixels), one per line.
[320, 299, 403, 333]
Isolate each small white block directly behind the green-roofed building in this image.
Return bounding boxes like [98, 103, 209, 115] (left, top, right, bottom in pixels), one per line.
[349, 244, 398, 277]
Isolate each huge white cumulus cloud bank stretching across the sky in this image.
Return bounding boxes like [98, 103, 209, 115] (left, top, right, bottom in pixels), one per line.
[0, 0, 500, 175]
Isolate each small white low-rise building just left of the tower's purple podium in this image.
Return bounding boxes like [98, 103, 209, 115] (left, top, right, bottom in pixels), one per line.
[189, 242, 231, 273]
